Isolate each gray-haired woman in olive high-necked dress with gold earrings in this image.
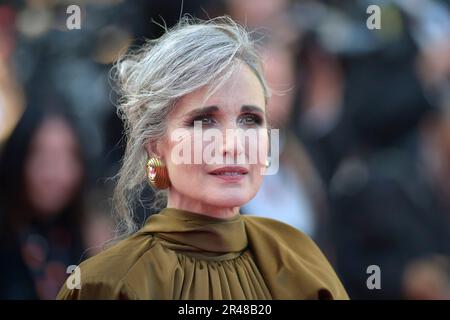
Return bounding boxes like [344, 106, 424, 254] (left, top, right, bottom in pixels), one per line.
[59, 17, 348, 299]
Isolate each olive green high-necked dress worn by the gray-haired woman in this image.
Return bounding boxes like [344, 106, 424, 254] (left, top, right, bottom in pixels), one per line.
[57, 208, 348, 299]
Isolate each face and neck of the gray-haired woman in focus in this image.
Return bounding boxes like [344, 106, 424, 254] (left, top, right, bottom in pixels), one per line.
[156, 63, 268, 217]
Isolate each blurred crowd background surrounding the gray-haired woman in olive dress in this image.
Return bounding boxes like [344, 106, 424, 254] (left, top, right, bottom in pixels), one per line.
[0, 0, 450, 299]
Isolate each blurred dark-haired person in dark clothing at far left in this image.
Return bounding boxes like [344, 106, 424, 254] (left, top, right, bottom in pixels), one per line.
[0, 105, 85, 299]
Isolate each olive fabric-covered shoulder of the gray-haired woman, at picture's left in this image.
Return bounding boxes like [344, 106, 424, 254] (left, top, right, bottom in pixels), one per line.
[57, 231, 168, 299]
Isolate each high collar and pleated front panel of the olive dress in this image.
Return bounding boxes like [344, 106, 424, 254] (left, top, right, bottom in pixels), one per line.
[131, 208, 271, 300]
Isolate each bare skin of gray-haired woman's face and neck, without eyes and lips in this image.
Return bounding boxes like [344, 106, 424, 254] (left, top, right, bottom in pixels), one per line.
[147, 63, 268, 218]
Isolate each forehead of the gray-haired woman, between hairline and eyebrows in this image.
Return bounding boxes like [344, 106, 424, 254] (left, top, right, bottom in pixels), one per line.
[174, 63, 265, 115]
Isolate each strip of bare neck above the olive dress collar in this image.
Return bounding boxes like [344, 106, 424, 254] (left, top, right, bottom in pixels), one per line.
[167, 192, 239, 219]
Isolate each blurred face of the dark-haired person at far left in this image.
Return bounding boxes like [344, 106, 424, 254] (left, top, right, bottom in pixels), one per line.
[25, 117, 83, 216]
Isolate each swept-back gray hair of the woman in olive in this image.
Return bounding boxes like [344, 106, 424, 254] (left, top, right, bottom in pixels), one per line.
[112, 16, 270, 237]
